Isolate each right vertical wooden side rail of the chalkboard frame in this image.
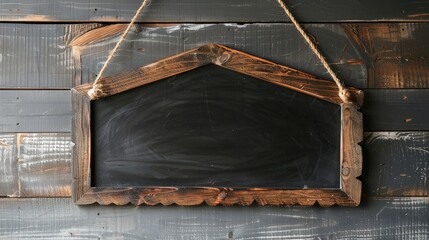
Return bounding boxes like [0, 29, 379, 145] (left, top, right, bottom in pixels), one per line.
[340, 104, 363, 206]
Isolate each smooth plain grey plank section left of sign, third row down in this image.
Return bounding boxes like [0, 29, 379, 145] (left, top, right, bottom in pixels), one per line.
[0, 90, 72, 132]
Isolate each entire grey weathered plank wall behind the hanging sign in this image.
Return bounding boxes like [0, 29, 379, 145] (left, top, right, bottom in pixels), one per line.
[0, 0, 429, 239]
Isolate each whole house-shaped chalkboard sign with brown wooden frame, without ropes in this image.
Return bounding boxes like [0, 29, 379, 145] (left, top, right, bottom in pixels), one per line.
[73, 45, 362, 205]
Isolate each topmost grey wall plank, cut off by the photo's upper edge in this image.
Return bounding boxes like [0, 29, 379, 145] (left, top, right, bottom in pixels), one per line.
[0, 0, 429, 22]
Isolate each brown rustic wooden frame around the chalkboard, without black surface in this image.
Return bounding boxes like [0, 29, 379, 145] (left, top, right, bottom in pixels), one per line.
[72, 44, 363, 206]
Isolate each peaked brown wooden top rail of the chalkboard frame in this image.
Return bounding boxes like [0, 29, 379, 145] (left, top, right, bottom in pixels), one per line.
[74, 44, 363, 107]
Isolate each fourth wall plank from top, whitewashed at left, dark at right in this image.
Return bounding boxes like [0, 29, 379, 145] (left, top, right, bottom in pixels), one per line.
[0, 132, 429, 197]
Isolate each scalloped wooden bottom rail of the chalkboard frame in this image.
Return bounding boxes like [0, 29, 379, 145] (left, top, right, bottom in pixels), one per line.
[75, 187, 356, 207]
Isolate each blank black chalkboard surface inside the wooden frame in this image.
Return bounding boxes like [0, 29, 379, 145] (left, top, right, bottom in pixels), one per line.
[91, 65, 341, 189]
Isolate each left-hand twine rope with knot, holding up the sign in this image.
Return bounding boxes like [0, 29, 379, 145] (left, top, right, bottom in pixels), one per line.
[88, 0, 149, 99]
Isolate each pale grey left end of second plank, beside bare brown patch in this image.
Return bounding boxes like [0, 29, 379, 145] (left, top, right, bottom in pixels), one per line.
[0, 24, 74, 88]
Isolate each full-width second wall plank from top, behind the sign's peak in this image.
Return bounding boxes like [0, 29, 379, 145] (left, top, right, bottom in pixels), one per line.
[0, 23, 429, 89]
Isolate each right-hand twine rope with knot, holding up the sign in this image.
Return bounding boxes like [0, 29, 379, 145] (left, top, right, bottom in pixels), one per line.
[277, 0, 350, 103]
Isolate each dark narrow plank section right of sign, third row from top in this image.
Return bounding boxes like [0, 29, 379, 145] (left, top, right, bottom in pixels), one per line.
[361, 89, 429, 131]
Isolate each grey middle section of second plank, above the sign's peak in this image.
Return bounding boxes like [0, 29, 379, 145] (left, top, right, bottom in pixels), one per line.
[76, 23, 367, 87]
